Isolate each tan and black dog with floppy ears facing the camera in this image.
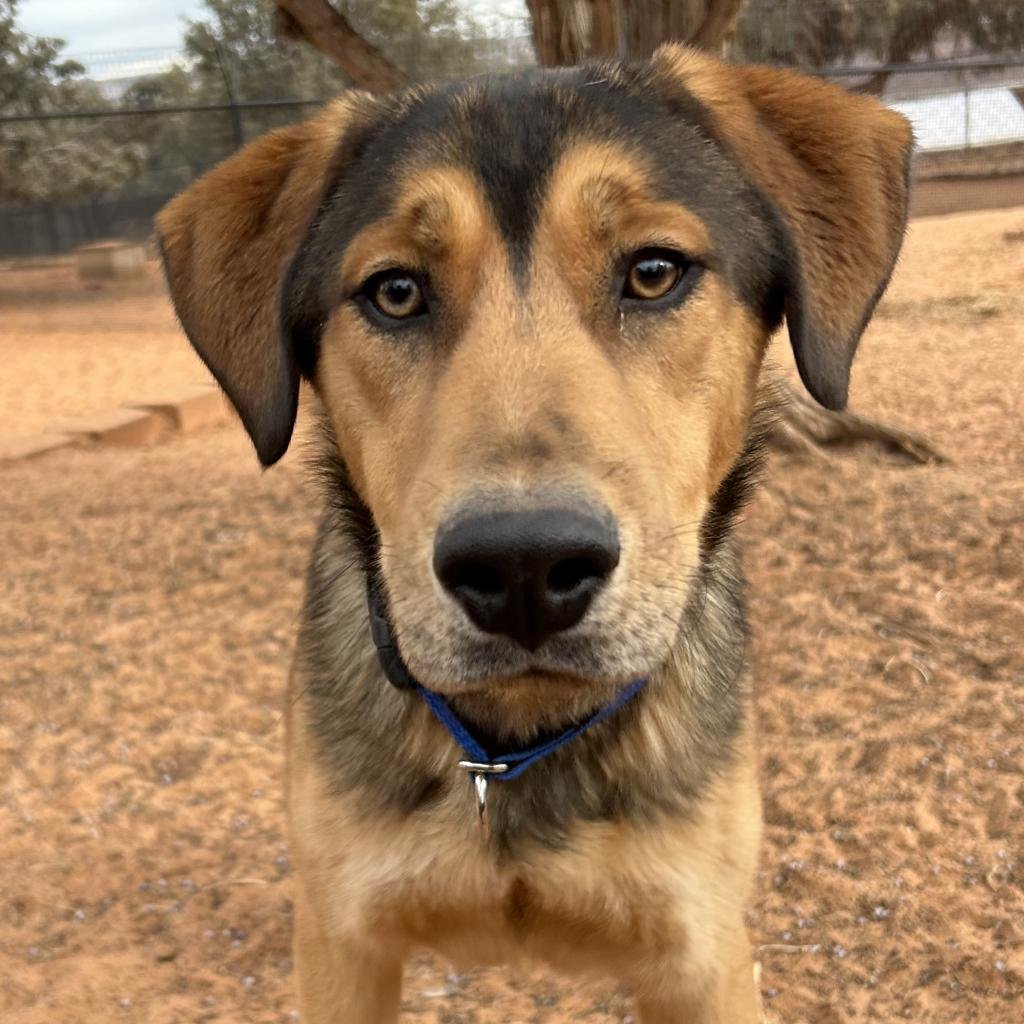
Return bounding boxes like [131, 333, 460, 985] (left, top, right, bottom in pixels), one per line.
[159, 47, 911, 1024]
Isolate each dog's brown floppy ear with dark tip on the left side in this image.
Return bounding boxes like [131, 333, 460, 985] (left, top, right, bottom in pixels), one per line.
[157, 98, 358, 466]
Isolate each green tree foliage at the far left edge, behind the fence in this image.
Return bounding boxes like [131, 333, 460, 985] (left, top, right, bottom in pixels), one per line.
[0, 0, 144, 202]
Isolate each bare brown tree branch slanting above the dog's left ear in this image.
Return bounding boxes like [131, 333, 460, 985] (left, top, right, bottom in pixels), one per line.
[274, 0, 409, 92]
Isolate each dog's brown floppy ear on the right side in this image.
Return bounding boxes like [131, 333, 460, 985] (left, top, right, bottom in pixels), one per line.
[654, 46, 912, 409]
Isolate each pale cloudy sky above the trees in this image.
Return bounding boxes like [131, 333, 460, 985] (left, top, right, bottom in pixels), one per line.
[17, 0, 523, 55]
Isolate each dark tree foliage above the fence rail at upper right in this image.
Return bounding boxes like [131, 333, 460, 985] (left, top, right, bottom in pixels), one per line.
[732, 0, 1024, 68]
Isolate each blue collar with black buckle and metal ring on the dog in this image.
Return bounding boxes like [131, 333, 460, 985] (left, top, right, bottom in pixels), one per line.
[367, 584, 647, 786]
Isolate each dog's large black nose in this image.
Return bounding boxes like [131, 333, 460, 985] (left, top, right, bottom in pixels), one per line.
[434, 509, 618, 650]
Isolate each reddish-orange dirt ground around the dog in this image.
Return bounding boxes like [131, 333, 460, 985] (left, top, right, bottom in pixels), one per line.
[6, 208, 1024, 1024]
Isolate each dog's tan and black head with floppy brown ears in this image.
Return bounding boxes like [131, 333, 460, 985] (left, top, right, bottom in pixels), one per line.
[159, 47, 910, 704]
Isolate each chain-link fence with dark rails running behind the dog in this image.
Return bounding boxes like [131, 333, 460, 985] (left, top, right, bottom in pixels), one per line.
[0, 33, 1024, 258]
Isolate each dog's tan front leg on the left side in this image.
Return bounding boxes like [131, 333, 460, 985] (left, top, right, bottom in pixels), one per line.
[294, 895, 401, 1024]
